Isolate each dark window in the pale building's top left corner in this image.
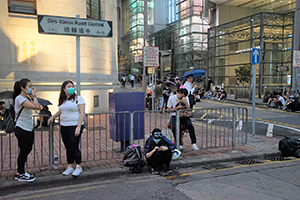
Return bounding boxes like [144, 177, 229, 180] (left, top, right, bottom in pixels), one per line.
[8, 0, 36, 15]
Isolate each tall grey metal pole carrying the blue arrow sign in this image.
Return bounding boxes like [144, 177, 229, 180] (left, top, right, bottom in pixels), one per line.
[250, 19, 256, 136]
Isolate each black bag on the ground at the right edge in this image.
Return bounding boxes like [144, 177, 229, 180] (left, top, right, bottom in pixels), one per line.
[278, 136, 300, 157]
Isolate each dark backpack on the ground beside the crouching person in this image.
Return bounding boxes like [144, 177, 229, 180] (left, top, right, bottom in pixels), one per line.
[123, 145, 146, 173]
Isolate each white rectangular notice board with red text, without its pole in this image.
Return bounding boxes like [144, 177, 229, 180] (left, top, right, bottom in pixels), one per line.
[143, 46, 159, 67]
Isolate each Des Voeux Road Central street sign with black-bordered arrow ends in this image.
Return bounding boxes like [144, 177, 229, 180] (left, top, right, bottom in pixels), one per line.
[38, 15, 112, 37]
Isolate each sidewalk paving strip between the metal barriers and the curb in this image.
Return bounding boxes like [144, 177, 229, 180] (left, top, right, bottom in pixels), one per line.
[0, 135, 280, 189]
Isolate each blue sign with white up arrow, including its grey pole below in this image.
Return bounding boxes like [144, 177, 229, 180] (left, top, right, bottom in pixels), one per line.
[251, 48, 260, 136]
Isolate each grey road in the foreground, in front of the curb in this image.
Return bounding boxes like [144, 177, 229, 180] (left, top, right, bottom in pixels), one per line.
[0, 158, 300, 200]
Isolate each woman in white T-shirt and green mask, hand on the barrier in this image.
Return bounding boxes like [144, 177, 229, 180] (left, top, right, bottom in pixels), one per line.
[48, 80, 85, 177]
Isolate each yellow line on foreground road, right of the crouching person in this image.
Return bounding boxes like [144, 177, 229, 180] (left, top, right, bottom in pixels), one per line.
[164, 158, 300, 179]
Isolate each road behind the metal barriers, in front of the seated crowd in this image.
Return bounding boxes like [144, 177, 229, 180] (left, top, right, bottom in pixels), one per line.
[194, 100, 300, 136]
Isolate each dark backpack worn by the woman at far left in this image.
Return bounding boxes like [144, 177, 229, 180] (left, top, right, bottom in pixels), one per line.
[3, 104, 24, 133]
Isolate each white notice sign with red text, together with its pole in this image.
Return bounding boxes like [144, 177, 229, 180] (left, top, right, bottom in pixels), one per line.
[143, 46, 159, 112]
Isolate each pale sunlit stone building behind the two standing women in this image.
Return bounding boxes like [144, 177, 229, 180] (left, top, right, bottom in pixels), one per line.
[0, 0, 119, 112]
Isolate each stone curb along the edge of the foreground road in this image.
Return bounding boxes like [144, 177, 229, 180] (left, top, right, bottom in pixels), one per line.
[0, 152, 281, 194]
